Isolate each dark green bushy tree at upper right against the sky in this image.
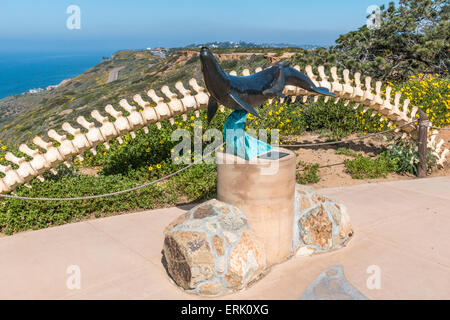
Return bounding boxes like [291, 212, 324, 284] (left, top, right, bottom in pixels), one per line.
[295, 0, 450, 80]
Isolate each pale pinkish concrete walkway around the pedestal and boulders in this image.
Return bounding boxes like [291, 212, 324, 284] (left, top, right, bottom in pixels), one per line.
[0, 177, 450, 299]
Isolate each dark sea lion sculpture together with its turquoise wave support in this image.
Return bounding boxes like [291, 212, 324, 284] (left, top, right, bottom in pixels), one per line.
[200, 47, 335, 160]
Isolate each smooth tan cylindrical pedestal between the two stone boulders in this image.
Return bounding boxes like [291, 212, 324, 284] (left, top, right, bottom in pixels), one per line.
[216, 149, 296, 266]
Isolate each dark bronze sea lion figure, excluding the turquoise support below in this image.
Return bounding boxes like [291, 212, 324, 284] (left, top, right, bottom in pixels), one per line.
[200, 47, 335, 122]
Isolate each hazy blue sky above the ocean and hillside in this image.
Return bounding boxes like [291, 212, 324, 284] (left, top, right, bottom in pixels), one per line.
[0, 0, 398, 51]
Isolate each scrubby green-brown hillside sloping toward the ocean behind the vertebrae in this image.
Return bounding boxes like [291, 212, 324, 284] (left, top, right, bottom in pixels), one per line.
[0, 48, 298, 146]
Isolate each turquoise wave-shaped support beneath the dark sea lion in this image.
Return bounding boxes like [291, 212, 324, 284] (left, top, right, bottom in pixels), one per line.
[223, 110, 272, 160]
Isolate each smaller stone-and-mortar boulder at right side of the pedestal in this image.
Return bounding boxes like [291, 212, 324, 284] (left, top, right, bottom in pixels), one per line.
[293, 185, 353, 256]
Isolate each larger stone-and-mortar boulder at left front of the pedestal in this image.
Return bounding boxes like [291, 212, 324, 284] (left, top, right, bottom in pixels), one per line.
[163, 200, 266, 296]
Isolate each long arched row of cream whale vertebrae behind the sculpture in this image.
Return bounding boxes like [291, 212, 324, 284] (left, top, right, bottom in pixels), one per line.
[0, 66, 449, 193]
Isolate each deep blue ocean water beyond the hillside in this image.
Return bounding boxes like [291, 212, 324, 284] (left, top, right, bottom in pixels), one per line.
[0, 51, 113, 99]
